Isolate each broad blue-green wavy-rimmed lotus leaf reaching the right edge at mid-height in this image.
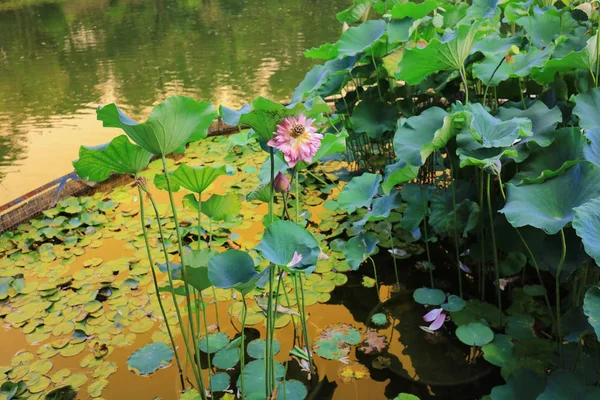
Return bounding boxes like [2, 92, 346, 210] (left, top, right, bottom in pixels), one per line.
[499, 161, 600, 235]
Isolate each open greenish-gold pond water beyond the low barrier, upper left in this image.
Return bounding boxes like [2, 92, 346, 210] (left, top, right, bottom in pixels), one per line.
[0, 0, 350, 204]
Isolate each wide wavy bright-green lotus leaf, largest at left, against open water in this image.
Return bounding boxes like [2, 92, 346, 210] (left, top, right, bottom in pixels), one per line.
[96, 96, 217, 155]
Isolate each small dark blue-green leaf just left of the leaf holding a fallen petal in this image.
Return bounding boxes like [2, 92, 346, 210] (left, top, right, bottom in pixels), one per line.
[208, 250, 260, 293]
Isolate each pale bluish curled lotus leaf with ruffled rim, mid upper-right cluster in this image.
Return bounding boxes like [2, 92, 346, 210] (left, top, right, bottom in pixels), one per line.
[464, 103, 533, 148]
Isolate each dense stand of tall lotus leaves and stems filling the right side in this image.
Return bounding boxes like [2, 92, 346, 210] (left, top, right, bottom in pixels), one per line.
[294, 0, 600, 400]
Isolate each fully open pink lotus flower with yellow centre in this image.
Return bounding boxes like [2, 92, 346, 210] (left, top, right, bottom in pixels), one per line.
[267, 114, 323, 168]
